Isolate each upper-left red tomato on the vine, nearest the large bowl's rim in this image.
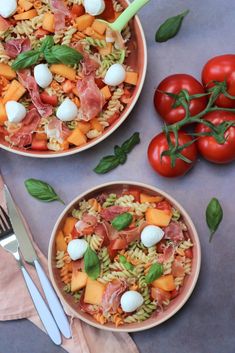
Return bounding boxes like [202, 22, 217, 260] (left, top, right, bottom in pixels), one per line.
[154, 74, 207, 124]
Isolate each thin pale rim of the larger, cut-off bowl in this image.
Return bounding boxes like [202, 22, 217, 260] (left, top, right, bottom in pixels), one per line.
[0, 11, 148, 158]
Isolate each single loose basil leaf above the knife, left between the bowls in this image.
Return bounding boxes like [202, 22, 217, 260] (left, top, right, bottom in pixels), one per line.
[24, 179, 64, 204]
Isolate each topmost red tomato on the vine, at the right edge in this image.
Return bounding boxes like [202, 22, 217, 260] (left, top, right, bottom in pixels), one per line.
[202, 54, 235, 108]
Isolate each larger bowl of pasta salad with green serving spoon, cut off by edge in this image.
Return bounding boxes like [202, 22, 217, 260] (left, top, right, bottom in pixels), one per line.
[0, 0, 147, 158]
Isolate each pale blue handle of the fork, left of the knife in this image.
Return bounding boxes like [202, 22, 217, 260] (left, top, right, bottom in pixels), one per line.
[21, 266, 61, 345]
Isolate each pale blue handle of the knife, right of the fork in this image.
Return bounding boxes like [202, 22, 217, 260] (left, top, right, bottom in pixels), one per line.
[34, 260, 71, 338]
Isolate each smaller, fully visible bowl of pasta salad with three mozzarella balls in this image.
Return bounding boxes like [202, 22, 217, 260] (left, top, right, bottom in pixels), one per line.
[48, 182, 201, 332]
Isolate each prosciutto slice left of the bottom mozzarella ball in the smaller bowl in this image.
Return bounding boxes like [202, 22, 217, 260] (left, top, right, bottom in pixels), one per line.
[102, 279, 127, 313]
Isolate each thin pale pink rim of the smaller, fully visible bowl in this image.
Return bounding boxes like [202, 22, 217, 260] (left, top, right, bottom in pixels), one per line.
[48, 181, 201, 332]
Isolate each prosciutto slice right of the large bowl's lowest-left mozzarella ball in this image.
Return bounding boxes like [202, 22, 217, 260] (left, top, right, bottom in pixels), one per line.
[9, 108, 41, 148]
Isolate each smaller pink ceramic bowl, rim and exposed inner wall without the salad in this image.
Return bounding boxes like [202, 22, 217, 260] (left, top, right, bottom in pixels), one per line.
[48, 181, 201, 332]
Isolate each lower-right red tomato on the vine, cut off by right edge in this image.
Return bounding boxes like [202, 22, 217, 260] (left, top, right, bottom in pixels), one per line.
[196, 111, 235, 164]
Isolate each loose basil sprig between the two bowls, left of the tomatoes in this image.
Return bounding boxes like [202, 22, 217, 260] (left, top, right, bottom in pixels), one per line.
[94, 132, 140, 174]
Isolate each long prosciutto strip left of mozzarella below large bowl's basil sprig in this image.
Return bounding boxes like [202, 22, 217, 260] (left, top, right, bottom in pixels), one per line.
[18, 70, 53, 117]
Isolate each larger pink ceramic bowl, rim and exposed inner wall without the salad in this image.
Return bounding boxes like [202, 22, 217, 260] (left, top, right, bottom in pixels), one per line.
[0, 0, 147, 158]
